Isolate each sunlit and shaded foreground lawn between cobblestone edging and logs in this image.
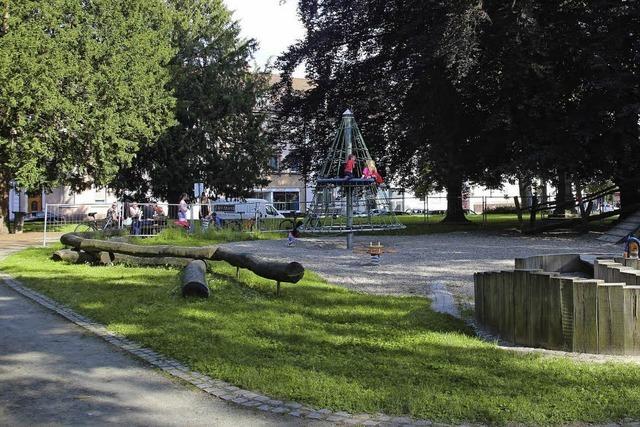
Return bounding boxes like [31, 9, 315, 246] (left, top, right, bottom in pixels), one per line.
[0, 248, 640, 424]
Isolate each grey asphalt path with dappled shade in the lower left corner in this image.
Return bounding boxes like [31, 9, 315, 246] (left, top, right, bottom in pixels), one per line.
[0, 237, 328, 426]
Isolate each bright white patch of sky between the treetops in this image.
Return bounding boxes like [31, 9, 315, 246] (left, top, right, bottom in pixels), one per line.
[224, 0, 305, 77]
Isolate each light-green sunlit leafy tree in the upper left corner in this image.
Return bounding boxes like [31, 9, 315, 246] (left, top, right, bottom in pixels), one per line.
[0, 0, 174, 232]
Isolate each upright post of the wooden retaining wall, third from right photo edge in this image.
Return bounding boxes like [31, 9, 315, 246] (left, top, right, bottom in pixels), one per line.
[573, 280, 604, 353]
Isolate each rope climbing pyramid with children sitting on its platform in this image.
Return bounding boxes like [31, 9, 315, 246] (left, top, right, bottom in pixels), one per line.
[301, 110, 405, 249]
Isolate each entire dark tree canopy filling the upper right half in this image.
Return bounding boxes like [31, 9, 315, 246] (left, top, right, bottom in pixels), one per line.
[278, 0, 640, 220]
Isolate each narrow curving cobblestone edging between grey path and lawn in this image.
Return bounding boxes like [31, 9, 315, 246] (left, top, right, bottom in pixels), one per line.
[0, 273, 445, 426]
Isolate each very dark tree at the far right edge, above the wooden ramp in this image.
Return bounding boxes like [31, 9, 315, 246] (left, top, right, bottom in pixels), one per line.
[480, 0, 640, 210]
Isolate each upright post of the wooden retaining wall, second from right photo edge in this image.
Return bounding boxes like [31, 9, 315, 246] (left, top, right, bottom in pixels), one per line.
[598, 283, 624, 354]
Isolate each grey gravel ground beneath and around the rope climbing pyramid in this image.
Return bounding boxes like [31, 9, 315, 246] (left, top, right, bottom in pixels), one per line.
[228, 232, 622, 315]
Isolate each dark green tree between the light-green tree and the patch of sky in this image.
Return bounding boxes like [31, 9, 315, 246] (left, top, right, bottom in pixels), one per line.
[113, 0, 272, 202]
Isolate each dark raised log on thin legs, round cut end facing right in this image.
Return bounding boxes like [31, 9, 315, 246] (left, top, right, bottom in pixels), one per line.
[212, 248, 304, 283]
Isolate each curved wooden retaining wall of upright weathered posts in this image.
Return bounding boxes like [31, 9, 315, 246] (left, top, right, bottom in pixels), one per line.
[474, 257, 640, 355]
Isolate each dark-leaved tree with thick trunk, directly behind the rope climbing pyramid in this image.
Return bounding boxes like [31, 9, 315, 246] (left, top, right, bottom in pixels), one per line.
[278, 0, 505, 221]
